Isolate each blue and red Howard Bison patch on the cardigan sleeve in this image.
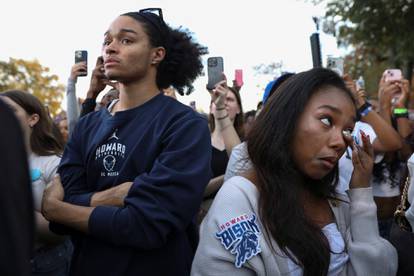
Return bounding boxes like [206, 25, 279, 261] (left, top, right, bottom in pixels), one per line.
[216, 214, 261, 268]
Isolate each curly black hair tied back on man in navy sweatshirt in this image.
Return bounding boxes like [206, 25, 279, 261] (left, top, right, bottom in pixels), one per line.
[122, 12, 208, 95]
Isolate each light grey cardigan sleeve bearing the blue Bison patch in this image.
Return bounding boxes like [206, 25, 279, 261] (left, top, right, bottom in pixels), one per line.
[191, 177, 261, 276]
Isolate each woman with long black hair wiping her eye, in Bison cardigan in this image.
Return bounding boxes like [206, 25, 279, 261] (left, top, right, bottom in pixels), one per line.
[192, 68, 397, 275]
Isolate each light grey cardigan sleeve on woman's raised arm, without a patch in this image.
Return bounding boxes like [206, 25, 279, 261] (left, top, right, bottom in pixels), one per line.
[346, 187, 398, 276]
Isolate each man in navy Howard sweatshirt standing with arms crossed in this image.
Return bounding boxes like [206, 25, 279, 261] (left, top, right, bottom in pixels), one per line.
[42, 11, 211, 276]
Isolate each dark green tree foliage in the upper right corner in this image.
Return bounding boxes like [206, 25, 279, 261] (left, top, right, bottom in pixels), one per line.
[312, 0, 414, 97]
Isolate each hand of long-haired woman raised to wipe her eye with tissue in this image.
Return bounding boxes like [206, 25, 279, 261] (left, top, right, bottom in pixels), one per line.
[348, 131, 374, 189]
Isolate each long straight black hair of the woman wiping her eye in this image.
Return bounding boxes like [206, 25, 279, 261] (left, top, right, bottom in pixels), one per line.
[247, 68, 356, 276]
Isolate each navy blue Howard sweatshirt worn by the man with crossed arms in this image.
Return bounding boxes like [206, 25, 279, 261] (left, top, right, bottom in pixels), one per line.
[58, 94, 211, 276]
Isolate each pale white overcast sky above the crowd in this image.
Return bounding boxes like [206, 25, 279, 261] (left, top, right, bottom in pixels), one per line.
[0, 0, 340, 112]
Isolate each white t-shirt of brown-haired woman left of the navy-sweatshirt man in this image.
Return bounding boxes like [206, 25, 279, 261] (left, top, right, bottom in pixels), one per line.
[29, 153, 60, 212]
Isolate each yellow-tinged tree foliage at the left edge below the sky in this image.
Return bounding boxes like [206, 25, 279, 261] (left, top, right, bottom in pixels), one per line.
[0, 58, 65, 116]
